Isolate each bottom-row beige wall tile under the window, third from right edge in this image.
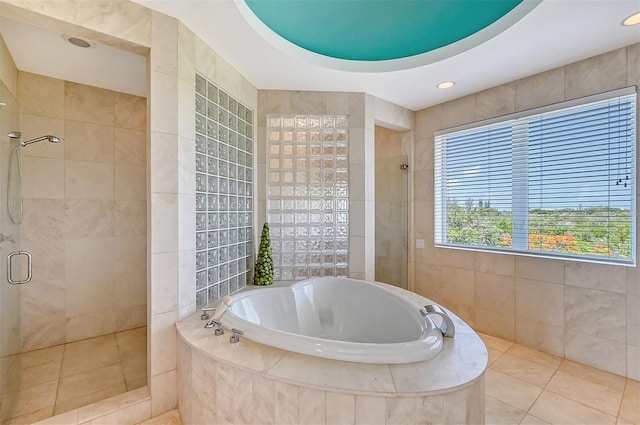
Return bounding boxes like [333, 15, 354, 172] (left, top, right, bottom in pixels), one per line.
[515, 317, 564, 357]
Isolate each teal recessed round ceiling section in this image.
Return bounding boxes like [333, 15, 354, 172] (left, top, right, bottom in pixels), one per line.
[245, 0, 525, 61]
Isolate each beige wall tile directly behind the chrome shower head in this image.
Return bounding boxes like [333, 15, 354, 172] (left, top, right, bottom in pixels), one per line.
[21, 113, 67, 159]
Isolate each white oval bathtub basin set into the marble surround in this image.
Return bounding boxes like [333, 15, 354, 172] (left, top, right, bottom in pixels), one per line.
[221, 277, 442, 364]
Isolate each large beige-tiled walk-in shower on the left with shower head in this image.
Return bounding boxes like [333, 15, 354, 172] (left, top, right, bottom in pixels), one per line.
[0, 22, 147, 423]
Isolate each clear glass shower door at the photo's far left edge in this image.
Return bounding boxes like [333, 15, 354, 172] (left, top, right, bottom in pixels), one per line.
[0, 81, 22, 423]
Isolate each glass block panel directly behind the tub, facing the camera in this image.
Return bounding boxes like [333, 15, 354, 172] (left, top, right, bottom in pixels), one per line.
[267, 115, 349, 280]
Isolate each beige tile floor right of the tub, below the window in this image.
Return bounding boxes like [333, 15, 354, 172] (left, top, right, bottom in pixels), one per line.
[480, 334, 640, 425]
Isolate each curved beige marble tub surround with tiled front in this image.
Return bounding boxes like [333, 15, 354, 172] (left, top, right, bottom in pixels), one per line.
[176, 288, 488, 424]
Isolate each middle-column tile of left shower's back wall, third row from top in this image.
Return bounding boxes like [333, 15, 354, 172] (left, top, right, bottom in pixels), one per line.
[66, 161, 114, 200]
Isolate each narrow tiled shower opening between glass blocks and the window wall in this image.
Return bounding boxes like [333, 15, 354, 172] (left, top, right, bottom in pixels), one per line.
[375, 126, 410, 289]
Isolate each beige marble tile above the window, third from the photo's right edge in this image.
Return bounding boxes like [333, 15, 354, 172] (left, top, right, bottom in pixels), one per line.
[516, 68, 564, 111]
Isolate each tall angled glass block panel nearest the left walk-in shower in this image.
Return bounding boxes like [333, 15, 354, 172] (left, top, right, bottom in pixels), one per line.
[196, 74, 253, 308]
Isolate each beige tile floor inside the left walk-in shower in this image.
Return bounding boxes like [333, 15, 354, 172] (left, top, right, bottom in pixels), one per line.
[0, 327, 147, 425]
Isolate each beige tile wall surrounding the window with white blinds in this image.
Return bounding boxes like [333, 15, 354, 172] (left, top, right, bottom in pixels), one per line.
[413, 44, 640, 379]
